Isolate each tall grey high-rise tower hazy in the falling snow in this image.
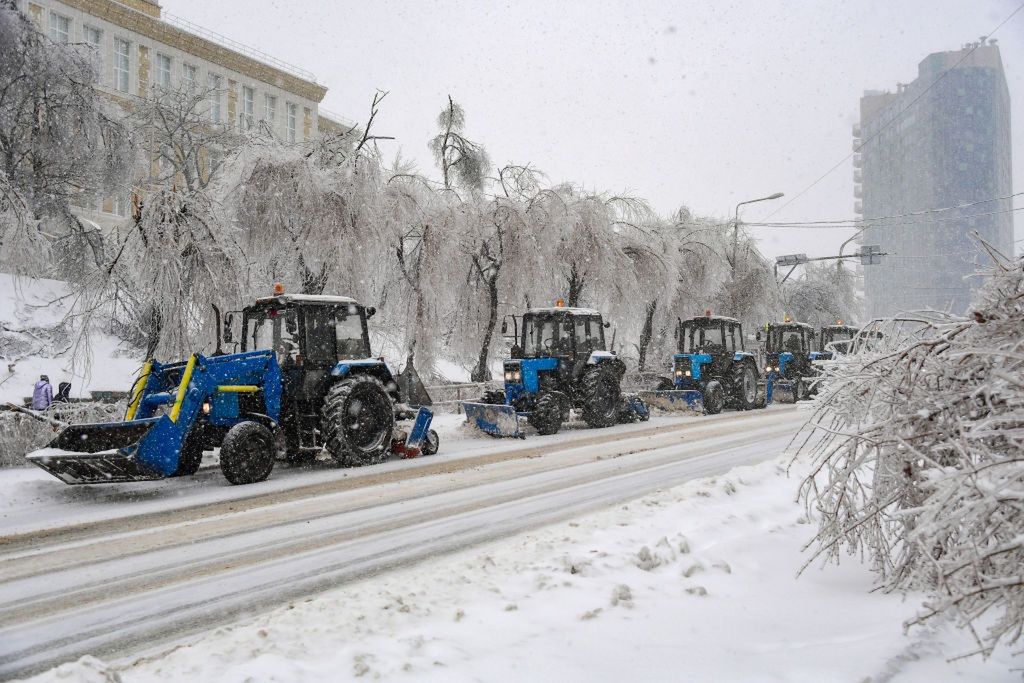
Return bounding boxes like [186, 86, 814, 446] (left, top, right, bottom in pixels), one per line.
[853, 41, 1014, 317]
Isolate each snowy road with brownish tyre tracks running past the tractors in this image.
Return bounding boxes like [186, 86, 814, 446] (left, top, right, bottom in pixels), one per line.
[0, 408, 806, 678]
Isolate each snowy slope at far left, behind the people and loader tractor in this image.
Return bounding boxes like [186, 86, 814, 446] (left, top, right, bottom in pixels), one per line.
[0, 273, 141, 403]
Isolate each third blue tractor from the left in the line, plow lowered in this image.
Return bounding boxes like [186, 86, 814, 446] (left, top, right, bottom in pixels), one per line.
[640, 310, 765, 415]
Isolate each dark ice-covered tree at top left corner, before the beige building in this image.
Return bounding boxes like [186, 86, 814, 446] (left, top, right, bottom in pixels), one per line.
[0, 0, 134, 272]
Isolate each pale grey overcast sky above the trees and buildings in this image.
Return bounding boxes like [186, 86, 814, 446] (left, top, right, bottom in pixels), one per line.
[162, 0, 1024, 256]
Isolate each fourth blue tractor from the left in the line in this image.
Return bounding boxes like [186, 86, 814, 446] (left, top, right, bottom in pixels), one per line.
[758, 316, 817, 403]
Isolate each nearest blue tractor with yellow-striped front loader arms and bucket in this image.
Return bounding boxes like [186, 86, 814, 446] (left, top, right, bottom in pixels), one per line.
[29, 290, 438, 484]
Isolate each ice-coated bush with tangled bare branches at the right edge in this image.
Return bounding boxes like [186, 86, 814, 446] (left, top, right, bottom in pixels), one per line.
[800, 246, 1024, 654]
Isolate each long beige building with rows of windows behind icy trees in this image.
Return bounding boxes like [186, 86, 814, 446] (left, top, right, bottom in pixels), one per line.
[18, 0, 349, 227]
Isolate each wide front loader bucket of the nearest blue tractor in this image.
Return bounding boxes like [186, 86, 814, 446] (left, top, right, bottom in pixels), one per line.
[27, 420, 164, 484]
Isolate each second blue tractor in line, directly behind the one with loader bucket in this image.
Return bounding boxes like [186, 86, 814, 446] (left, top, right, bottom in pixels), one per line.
[463, 302, 649, 436]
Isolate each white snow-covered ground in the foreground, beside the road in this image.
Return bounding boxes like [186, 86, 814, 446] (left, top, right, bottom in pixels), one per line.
[22, 448, 1019, 683]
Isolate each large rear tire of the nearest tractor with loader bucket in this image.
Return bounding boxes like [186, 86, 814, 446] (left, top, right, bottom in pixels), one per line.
[321, 375, 394, 467]
